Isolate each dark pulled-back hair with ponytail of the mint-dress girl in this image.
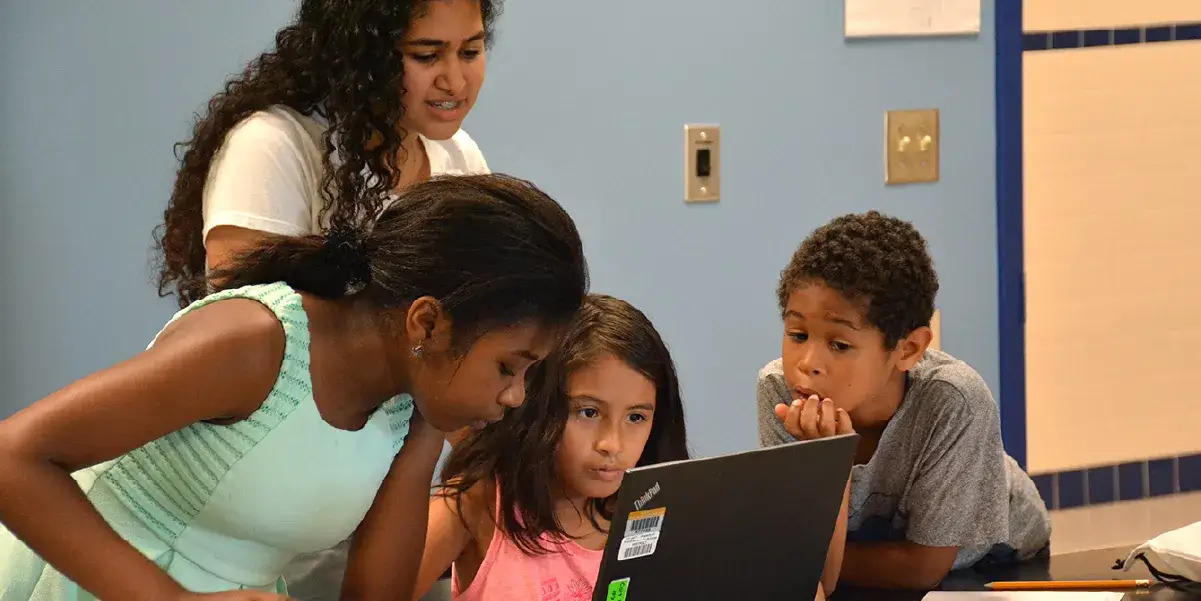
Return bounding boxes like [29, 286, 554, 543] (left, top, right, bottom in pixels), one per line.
[209, 174, 588, 341]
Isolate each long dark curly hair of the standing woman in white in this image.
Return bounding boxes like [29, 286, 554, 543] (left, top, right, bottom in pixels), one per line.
[154, 0, 502, 307]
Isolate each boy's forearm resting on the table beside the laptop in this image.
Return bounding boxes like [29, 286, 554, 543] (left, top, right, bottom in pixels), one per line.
[842, 541, 960, 590]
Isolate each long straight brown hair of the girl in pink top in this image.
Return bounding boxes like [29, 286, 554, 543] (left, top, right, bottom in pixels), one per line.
[436, 294, 689, 555]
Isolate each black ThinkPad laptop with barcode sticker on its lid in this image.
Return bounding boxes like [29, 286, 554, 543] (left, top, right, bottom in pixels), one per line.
[592, 434, 859, 601]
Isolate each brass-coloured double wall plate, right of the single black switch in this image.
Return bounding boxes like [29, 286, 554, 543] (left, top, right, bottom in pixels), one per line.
[884, 108, 942, 185]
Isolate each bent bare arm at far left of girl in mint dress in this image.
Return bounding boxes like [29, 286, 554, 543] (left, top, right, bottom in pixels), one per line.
[0, 301, 283, 601]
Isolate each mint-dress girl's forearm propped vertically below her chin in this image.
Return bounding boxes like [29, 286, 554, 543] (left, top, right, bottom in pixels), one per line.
[342, 411, 446, 601]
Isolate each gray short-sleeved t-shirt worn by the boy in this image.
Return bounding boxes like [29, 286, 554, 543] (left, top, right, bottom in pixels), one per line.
[758, 350, 1051, 569]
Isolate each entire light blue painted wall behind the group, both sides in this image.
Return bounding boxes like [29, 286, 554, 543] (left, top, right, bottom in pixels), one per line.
[0, 0, 998, 454]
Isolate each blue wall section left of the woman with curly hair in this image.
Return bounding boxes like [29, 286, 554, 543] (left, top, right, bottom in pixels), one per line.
[0, 0, 295, 416]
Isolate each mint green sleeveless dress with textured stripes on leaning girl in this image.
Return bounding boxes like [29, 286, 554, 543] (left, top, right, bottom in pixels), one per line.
[0, 284, 413, 601]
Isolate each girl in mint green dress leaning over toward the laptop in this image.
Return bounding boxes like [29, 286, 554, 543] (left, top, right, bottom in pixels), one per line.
[0, 175, 587, 601]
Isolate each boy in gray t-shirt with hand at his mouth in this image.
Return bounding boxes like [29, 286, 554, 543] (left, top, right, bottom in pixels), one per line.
[758, 212, 1051, 589]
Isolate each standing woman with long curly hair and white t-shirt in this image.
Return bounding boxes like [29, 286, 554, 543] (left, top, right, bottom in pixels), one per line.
[155, 0, 501, 308]
